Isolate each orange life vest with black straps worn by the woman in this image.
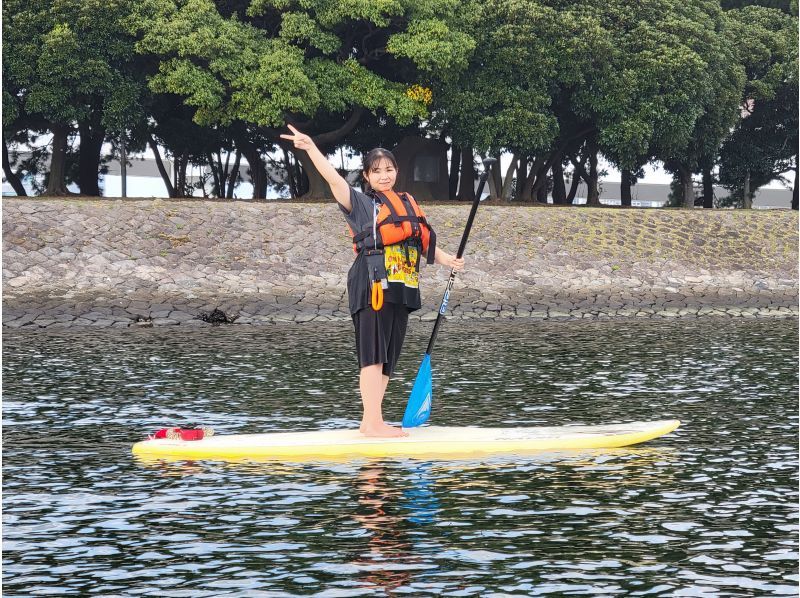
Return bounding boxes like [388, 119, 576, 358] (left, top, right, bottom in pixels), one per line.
[350, 191, 436, 264]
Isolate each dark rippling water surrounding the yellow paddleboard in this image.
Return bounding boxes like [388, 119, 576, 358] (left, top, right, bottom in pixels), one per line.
[3, 320, 798, 597]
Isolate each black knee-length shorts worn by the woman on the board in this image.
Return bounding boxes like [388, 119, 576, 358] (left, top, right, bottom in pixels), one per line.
[353, 302, 408, 376]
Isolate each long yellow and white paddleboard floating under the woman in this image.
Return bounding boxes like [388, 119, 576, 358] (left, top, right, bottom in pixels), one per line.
[133, 419, 680, 461]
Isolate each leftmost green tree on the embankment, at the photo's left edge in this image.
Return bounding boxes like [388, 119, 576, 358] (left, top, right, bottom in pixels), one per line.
[3, 0, 143, 195]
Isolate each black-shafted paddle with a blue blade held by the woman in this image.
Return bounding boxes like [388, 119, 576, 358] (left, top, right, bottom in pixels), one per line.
[403, 158, 497, 428]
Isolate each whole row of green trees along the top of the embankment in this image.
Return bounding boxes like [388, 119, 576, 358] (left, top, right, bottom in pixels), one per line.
[3, 0, 797, 206]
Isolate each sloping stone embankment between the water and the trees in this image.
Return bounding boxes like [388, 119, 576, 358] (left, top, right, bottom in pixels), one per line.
[3, 198, 798, 328]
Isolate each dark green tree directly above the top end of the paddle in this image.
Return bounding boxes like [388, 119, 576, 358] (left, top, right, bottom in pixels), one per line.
[424, 0, 559, 199]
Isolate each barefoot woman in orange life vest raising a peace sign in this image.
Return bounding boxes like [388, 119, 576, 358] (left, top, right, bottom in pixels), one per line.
[281, 125, 464, 437]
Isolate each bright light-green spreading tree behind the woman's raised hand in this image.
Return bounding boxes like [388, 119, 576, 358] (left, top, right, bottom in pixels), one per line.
[130, 0, 472, 202]
